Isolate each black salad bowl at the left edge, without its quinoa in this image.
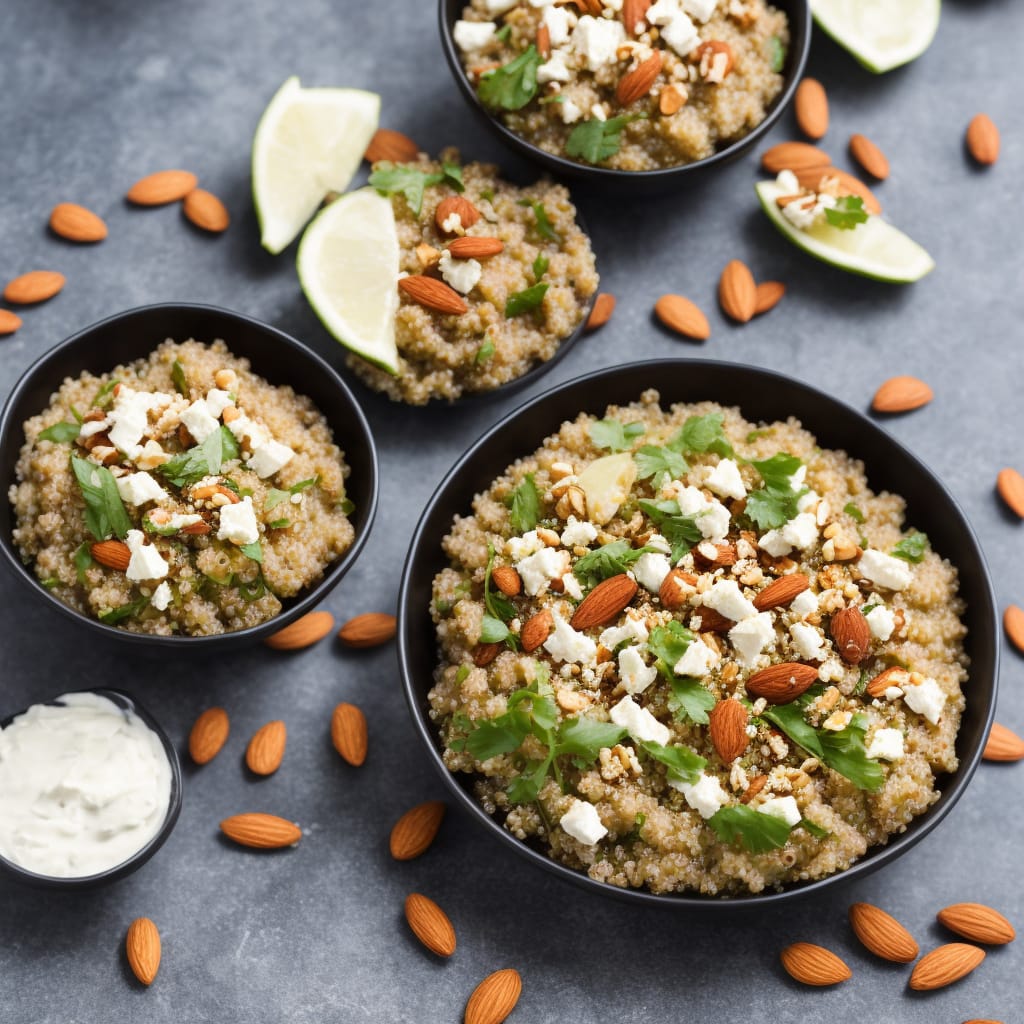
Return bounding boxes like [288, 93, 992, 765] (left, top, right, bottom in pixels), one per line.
[0, 302, 377, 650]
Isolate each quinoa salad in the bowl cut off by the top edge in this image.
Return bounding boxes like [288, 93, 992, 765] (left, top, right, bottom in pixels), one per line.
[453, 0, 790, 171]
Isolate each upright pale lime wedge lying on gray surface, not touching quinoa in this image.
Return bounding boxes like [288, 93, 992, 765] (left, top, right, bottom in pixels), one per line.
[253, 78, 381, 253]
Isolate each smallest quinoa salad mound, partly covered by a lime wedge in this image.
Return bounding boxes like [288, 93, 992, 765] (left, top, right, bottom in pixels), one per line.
[360, 150, 598, 406]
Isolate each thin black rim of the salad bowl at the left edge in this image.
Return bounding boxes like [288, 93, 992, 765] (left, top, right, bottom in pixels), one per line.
[0, 302, 380, 650]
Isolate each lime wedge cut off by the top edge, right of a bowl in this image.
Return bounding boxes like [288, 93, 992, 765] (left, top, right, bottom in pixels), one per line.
[811, 0, 940, 75]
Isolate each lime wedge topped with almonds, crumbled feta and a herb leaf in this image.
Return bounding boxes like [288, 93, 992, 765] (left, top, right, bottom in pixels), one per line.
[756, 181, 935, 284]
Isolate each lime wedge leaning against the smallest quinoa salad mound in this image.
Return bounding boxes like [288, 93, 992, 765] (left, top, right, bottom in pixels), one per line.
[296, 188, 398, 374]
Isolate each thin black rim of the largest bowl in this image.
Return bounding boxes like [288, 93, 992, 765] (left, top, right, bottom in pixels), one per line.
[397, 358, 999, 912]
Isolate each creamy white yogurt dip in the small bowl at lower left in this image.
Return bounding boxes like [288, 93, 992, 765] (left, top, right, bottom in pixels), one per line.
[0, 693, 171, 879]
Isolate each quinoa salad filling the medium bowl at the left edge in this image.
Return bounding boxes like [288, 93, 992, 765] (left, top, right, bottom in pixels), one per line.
[9, 340, 354, 636]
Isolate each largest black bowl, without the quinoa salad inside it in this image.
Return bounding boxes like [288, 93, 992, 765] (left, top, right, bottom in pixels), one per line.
[398, 359, 998, 909]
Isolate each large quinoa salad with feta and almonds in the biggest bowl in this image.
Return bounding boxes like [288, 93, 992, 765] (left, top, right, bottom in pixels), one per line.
[429, 391, 968, 896]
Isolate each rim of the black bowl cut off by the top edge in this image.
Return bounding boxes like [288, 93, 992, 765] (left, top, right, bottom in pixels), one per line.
[438, 0, 812, 185]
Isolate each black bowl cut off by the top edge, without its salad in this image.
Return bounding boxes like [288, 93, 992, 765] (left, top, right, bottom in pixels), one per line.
[438, 0, 811, 196]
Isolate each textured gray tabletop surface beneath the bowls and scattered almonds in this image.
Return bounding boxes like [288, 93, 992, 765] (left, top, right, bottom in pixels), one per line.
[0, 0, 1024, 1024]
